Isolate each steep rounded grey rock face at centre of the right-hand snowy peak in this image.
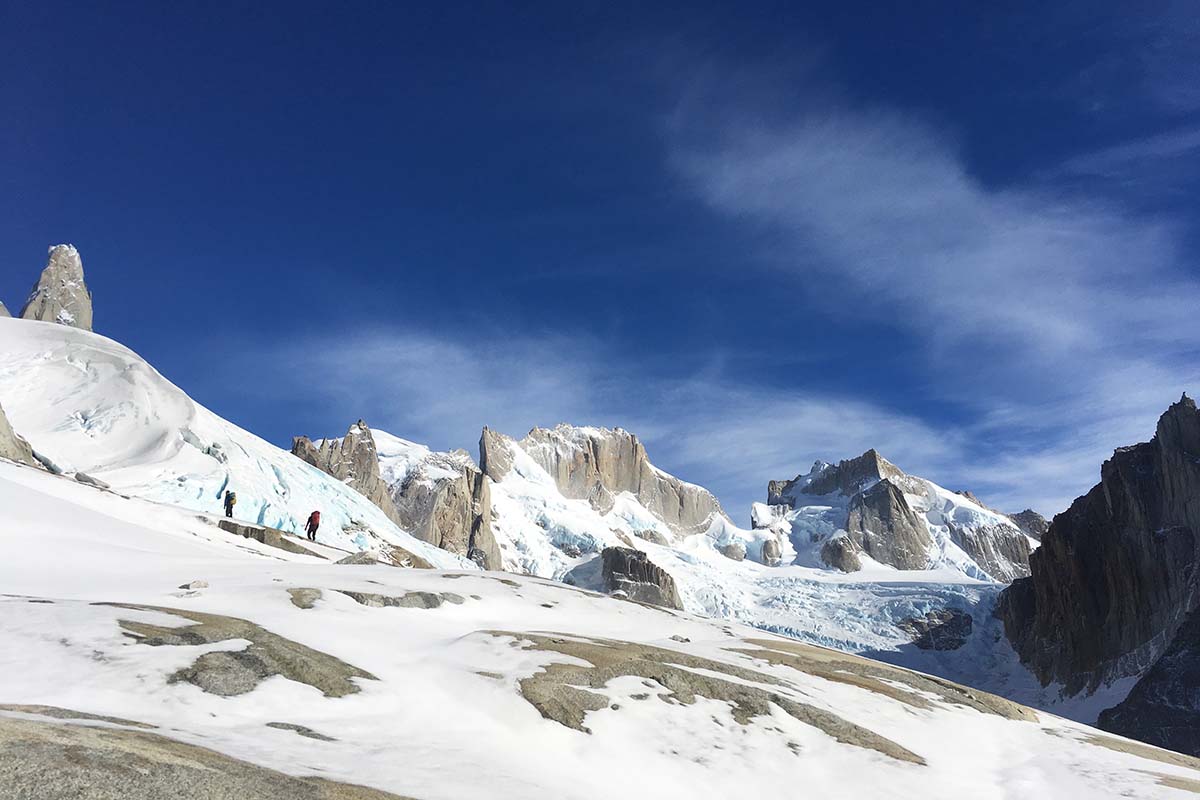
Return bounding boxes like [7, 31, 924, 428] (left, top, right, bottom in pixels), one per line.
[846, 479, 934, 570]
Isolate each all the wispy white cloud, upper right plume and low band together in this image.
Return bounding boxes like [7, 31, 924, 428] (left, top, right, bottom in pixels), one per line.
[231, 68, 1200, 521]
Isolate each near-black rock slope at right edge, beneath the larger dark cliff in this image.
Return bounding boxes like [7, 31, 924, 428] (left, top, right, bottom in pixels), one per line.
[1099, 612, 1200, 756]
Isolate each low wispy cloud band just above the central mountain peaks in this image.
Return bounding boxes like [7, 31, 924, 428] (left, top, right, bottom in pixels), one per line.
[241, 327, 962, 523]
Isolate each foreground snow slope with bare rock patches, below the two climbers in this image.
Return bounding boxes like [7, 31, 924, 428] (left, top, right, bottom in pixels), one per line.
[0, 463, 1200, 800]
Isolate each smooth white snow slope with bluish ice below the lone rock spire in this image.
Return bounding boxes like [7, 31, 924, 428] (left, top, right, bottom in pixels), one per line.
[0, 319, 469, 567]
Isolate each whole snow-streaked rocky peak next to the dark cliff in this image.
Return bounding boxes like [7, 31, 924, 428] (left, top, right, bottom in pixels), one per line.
[752, 450, 1030, 581]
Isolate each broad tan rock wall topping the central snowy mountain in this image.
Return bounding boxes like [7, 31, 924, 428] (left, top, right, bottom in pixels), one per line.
[480, 425, 728, 536]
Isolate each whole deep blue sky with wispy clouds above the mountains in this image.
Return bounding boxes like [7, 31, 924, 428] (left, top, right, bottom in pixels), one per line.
[0, 2, 1200, 522]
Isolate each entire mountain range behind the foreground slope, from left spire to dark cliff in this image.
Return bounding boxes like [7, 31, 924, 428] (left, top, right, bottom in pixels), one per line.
[0, 246, 1200, 767]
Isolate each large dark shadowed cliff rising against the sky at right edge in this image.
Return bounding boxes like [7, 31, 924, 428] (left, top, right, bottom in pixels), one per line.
[997, 395, 1200, 694]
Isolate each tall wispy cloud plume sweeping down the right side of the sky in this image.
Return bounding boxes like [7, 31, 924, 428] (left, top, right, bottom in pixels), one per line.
[671, 87, 1200, 511]
